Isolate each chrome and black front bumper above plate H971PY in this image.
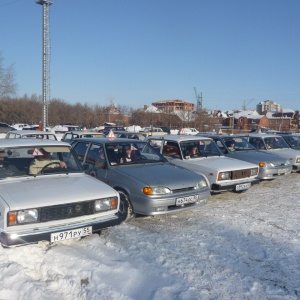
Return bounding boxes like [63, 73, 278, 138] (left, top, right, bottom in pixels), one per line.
[0, 214, 122, 247]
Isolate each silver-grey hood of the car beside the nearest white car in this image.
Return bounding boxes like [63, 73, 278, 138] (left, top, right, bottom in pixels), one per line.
[116, 163, 204, 189]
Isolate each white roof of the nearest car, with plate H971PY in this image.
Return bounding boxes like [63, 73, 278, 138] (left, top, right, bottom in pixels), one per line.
[0, 139, 70, 148]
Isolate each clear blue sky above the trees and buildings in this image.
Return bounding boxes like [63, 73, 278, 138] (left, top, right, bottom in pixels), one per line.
[0, 0, 300, 110]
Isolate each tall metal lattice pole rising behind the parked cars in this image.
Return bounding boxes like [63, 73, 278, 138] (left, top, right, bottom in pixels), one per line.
[36, 0, 52, 130]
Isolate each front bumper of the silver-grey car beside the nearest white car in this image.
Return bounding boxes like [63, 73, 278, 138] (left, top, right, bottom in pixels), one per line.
[130, 187, 210, 216]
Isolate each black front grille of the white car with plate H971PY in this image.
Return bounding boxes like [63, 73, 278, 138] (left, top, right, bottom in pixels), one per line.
[40, 201, 95, 222]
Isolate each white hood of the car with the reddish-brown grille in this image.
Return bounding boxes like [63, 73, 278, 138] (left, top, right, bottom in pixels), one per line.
[182, 156, 257, 171]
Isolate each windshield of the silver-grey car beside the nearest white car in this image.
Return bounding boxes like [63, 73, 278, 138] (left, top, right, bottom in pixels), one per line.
[105, 141, 166, 166]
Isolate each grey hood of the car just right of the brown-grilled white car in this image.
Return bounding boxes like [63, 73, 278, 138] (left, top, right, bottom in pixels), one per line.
[228, 151, 286, 164]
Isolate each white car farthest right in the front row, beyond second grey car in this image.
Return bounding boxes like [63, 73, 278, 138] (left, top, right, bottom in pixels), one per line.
[248, 133, 300, 172]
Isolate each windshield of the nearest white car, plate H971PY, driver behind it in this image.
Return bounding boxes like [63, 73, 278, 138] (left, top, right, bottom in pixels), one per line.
[0, 145, 82, 179]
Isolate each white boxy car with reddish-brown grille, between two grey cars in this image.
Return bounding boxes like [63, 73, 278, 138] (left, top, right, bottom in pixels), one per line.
[147, 135, 259, 193]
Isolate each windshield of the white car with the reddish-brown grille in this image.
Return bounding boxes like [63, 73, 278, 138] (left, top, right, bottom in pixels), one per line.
[180, 139, 223, 159]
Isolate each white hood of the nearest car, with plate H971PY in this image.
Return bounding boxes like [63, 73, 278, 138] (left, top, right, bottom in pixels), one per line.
[0, 173, 117, 210]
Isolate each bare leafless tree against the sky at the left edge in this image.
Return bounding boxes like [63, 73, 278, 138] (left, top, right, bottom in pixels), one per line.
[0, 53, 17, 98]
